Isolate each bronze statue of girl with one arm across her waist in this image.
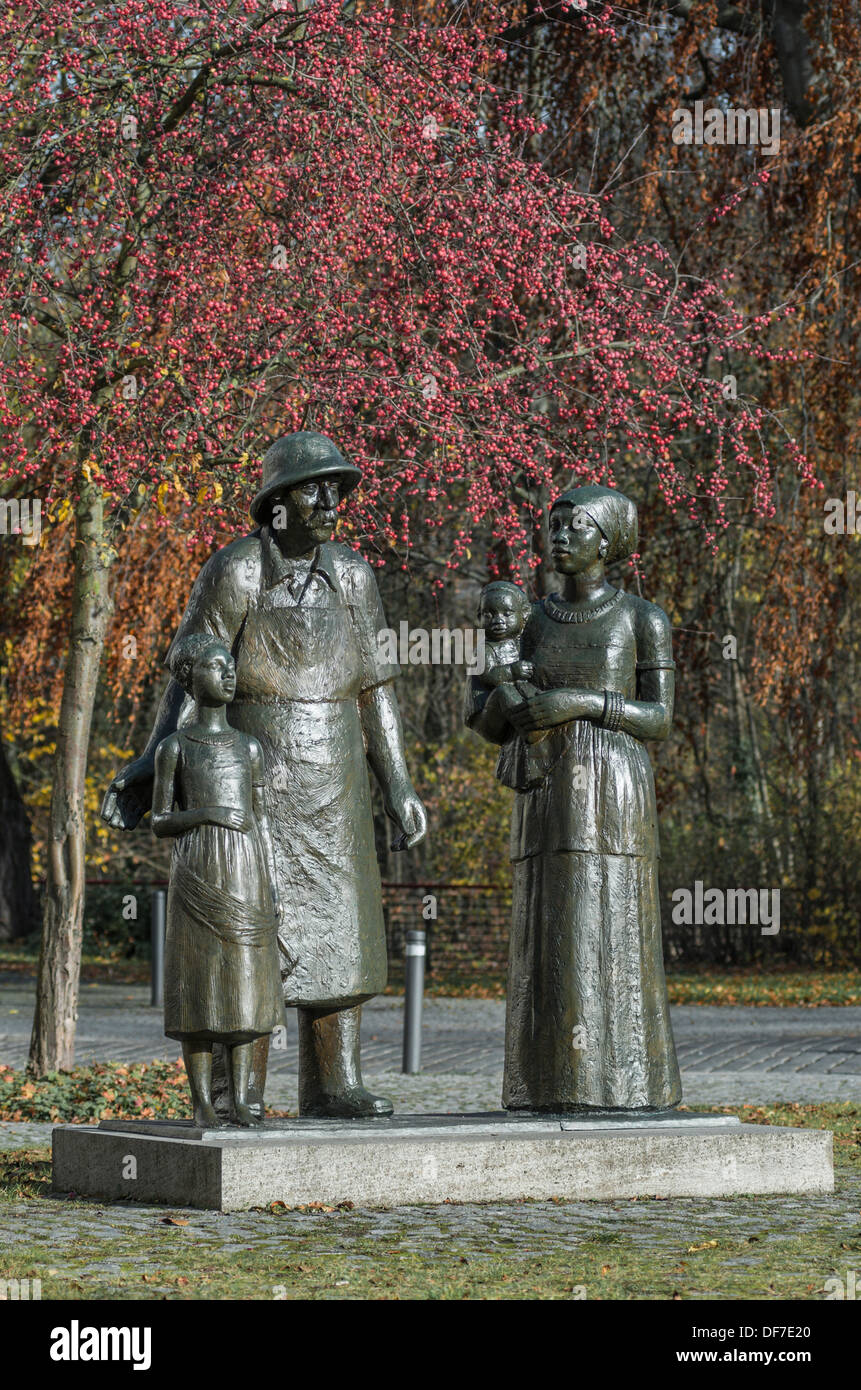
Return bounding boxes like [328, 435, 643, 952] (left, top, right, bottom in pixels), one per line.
[153, 634, 287, 1129]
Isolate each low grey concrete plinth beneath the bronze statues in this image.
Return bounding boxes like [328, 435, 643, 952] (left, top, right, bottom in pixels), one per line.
[53, 1113, 835, 1212]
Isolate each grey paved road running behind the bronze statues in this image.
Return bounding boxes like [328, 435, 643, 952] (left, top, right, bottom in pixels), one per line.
[0, 974, 861, 1143]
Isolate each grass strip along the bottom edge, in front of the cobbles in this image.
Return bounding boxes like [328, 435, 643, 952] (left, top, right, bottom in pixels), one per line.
[1, 1218, 861, 1301]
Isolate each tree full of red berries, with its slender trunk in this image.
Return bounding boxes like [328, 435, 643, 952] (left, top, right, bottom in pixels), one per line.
[0, 0, 811, 1072]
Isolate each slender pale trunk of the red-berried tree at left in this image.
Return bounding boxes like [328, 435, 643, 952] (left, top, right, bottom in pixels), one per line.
[29, 482, 110, 1076]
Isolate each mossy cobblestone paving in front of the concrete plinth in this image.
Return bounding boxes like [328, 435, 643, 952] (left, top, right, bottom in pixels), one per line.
[0, 1175, 861, 1301]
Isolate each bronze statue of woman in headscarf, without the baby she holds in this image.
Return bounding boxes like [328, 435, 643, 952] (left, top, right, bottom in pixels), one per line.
[467, 485, 682, 1112]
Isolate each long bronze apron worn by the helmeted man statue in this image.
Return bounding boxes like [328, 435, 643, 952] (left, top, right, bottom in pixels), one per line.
[228, 569, 387, 1008]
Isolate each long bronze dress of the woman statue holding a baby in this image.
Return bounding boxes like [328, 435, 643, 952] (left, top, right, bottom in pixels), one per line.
[501, 591, 682, 1112]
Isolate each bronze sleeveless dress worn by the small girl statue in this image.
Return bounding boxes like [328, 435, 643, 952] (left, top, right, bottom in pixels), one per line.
[164, 730, 284, 1043]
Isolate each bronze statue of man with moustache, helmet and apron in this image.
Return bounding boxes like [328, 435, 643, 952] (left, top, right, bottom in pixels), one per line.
[102, 431, 427, 1119]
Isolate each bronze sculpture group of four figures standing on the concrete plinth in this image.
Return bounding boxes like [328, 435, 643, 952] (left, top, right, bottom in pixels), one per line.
[103, 431, 680, 1127]
